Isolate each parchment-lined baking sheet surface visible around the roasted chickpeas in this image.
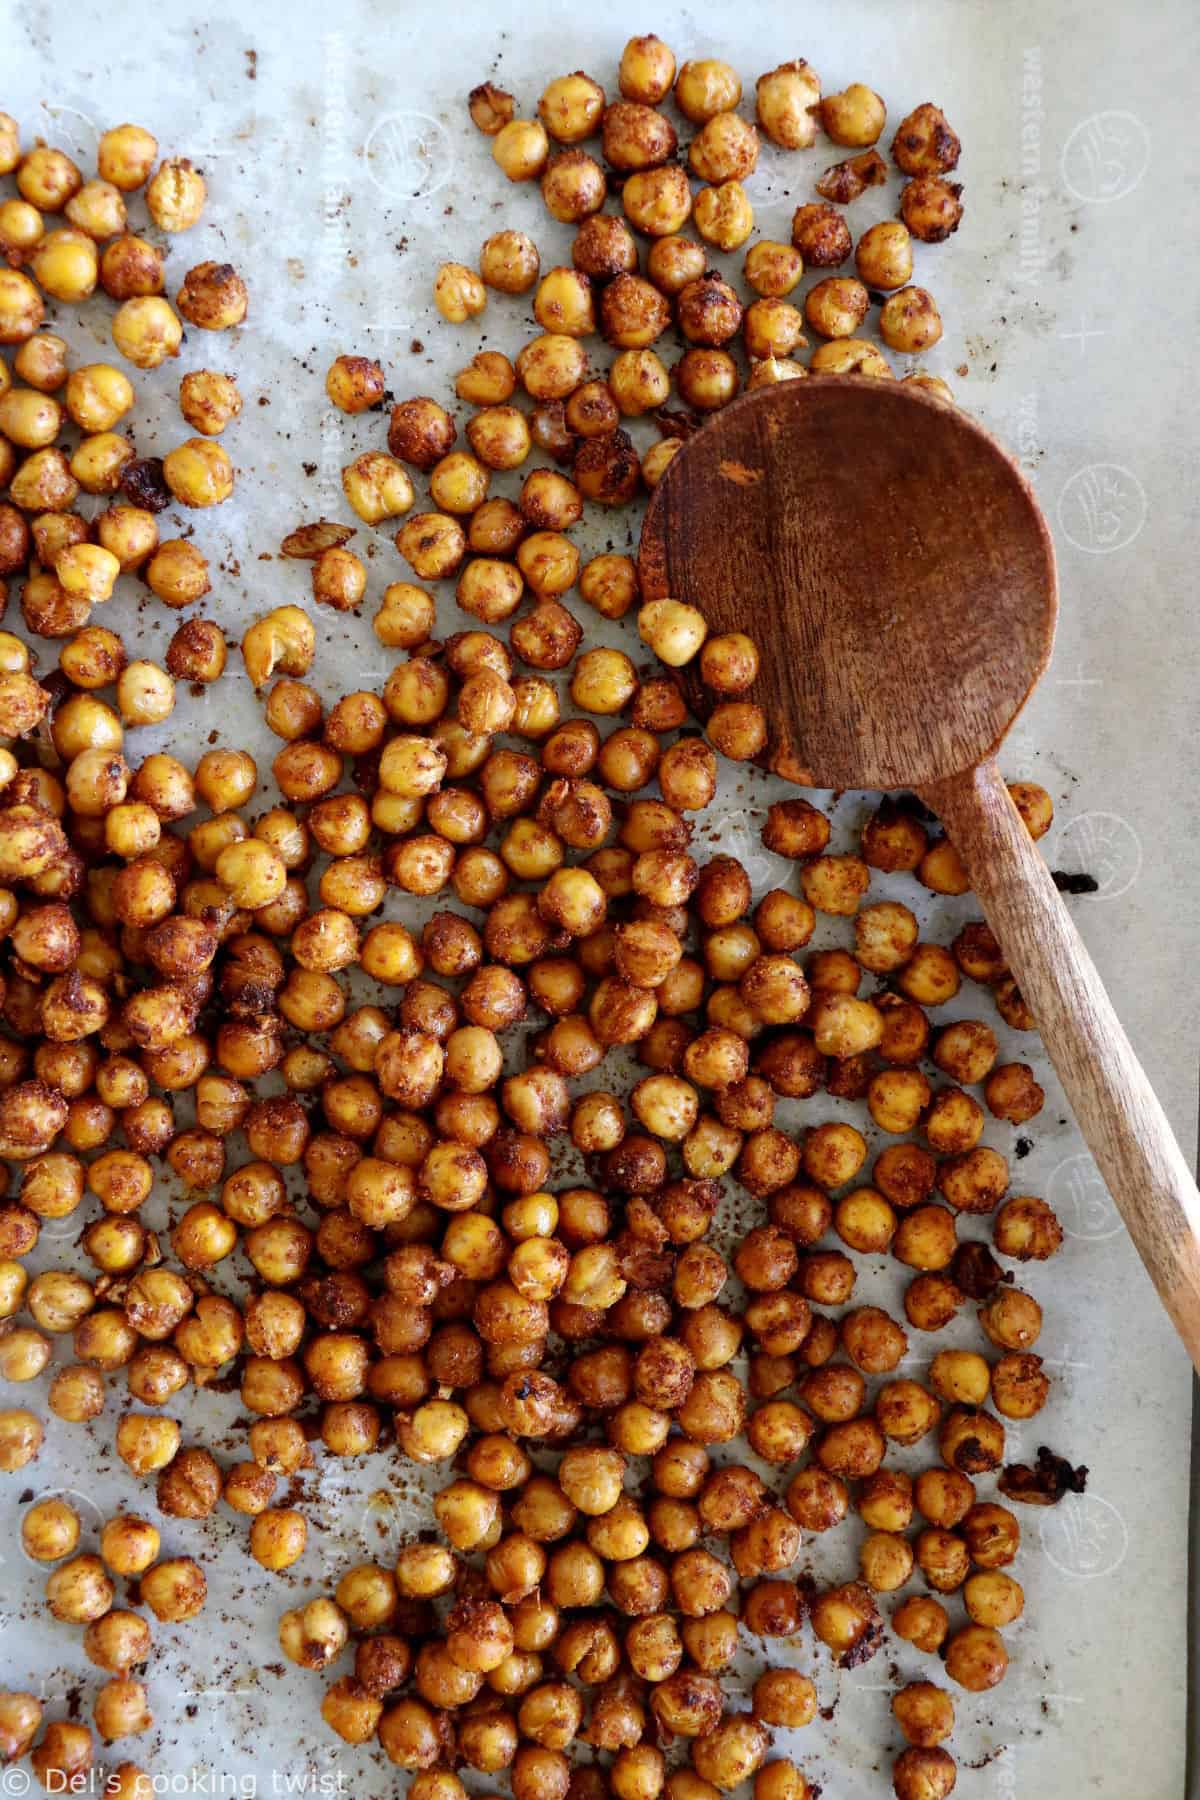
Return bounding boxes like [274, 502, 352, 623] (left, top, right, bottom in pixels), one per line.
[0, 0, 1200, 1800]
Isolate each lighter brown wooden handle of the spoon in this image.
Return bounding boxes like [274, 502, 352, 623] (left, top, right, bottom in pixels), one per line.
[921, 761, 1200, 1370]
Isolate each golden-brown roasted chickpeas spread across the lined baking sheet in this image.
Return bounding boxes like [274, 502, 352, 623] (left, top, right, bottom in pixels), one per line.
[0, 36, 1061, 1800]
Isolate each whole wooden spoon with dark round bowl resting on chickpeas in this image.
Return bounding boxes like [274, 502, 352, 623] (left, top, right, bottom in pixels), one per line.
[639, 376, 1200, 1368]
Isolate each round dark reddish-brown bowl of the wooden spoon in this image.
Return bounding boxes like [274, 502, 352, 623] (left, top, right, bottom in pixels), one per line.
[639, 376, 1058, 788]
